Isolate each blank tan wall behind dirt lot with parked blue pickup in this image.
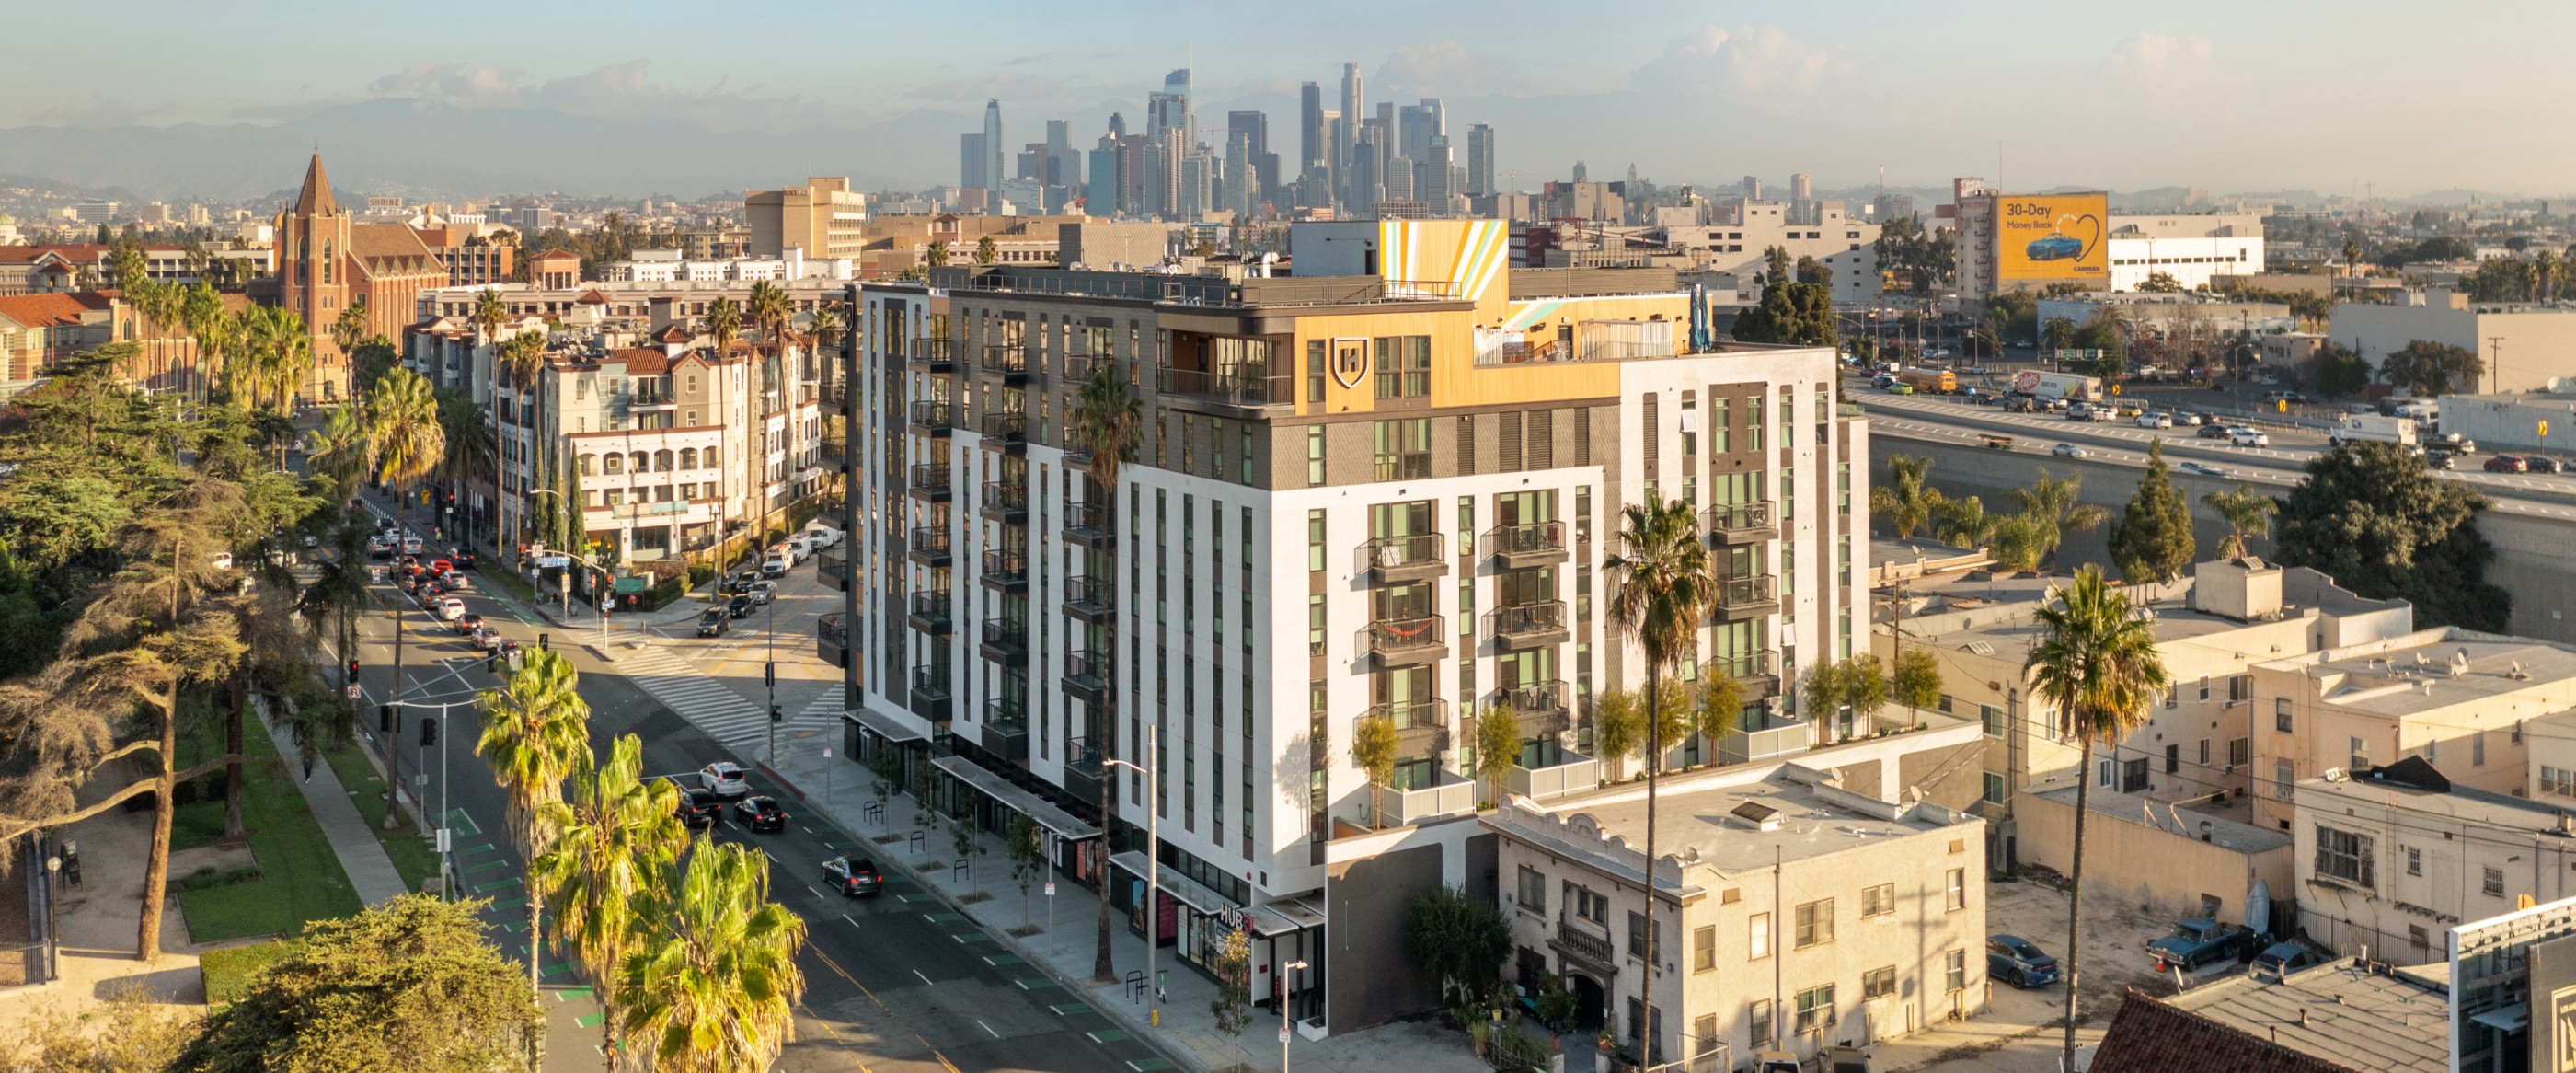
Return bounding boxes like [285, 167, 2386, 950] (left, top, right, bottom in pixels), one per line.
[2015, 791, 2298, 923]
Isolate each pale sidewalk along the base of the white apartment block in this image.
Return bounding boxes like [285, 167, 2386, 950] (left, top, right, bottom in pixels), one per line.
[773, 735, 1491, 1073]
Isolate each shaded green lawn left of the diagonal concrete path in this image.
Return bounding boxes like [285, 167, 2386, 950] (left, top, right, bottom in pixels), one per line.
[170, 722, 363, 941]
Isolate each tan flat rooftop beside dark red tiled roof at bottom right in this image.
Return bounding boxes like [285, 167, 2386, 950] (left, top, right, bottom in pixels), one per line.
[2164, 960, 2450, 1073]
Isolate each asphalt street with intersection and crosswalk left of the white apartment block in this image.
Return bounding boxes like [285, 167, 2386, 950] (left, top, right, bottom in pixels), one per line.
[335, 503, 1172, 1073]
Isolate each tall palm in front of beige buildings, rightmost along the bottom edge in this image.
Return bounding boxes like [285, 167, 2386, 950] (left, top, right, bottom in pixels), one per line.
[2022, 565, 2164, 1067]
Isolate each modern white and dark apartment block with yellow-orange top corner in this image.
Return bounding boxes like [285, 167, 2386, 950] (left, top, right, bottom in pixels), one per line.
[845, 222, 1868, 1029]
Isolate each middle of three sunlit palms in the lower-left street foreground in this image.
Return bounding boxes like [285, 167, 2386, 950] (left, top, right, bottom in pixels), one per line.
[528, 735, 688, 1067]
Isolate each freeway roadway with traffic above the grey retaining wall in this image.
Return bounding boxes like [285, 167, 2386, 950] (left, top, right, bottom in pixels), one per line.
[1845, 382, 2576, 518]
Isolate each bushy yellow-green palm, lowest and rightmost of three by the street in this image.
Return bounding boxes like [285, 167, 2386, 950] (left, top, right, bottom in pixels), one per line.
[618, 838, 806, 1073]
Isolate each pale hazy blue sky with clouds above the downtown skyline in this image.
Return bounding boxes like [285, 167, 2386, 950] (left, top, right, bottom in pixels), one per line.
[0, 0, 2576, 196]
